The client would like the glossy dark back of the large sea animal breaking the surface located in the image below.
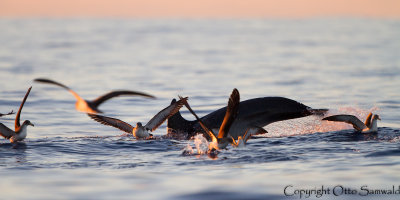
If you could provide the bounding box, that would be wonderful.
[167,97,328,139]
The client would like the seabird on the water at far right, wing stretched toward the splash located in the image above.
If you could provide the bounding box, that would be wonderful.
[322,113,381,133]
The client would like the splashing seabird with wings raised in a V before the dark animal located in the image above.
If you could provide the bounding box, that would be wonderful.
[181,88,260,152]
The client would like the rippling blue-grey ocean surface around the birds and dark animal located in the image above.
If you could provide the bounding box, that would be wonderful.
[0,18,400,199]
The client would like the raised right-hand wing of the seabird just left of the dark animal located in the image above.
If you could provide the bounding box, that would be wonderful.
[145,97,188,131]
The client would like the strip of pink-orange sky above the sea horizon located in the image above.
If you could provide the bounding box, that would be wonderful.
[0,0,400,18]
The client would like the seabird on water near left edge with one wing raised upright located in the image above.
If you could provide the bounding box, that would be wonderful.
[0,87,34,143]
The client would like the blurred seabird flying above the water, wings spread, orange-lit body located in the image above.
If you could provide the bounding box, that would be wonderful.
[34,78,155,113]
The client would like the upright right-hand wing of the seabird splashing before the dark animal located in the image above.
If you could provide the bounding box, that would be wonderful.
[218,88,240,138]
